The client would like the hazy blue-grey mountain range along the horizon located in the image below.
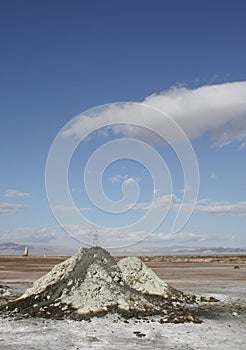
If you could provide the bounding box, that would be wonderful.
[0,242,246,256]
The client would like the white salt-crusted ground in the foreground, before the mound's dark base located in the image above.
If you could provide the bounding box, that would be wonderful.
[0,304,246,350]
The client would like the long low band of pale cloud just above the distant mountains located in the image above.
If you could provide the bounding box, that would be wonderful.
[0,225,237,250]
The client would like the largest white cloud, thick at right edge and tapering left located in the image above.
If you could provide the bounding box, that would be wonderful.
[63,81,246,146]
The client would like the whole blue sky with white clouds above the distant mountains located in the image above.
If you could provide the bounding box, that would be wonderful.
[0,0,246,249]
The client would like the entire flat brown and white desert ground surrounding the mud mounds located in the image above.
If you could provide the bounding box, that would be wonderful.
[0,256,246,350]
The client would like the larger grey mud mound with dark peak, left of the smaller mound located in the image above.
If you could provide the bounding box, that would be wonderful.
[1,247,200,323]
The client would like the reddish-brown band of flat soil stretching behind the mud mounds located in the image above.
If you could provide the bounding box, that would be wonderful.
[0,256,246,289]
